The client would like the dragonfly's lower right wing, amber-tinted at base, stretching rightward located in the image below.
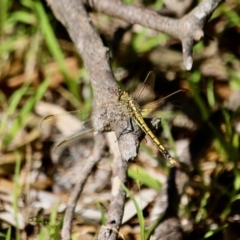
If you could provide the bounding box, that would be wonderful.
[141,89,186,118]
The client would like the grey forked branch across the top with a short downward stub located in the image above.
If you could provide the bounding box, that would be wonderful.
[85,0,222,70]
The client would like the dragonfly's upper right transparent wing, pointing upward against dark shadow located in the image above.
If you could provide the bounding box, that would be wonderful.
[132,71,155,105]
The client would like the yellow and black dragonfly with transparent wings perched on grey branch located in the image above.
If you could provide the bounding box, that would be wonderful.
[41,71,186,166]
